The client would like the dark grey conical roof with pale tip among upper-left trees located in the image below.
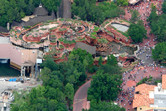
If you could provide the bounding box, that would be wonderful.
[33,4,48,16]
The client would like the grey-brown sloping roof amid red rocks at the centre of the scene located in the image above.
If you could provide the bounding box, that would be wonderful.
[75,42,96,55]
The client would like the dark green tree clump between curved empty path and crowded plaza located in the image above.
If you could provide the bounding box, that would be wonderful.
[88,55,122,102]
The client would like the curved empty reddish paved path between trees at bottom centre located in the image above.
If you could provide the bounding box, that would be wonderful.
[73,80,91,111]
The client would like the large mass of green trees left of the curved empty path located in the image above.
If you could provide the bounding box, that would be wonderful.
[11,49,93,111]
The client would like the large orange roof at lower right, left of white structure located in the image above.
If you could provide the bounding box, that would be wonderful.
[133,84,156,108]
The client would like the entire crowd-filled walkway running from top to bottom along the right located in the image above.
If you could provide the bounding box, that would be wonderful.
[116,0,166,111]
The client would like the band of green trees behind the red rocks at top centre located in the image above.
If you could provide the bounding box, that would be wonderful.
[72,0,124,25]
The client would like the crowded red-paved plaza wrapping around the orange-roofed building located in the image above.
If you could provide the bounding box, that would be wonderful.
[117,62,166,110]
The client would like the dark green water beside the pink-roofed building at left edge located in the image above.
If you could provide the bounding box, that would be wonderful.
[0,63,20,77]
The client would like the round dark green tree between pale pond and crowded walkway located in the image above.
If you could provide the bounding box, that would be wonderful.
[128,24,146,43]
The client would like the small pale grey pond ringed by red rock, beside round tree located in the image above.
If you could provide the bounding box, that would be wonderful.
[111,23,129,32]
